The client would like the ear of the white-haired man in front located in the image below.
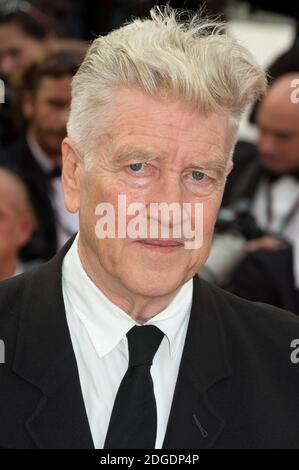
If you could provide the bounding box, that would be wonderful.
[61,138,83,213]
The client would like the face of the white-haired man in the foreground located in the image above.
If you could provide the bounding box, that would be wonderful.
[64,90,232,297]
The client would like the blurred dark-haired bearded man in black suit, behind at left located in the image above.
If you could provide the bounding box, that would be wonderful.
[0,41,86,260]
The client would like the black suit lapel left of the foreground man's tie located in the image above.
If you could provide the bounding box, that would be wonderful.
[14,239,93,449]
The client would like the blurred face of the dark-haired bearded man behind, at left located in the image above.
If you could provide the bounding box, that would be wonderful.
[25,76,71,158]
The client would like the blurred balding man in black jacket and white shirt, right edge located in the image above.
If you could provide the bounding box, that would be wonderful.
[224,72,299,314]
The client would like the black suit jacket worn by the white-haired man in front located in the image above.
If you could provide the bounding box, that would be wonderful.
[0,242,299,449]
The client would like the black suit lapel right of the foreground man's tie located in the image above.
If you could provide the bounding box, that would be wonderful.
[163,276,232,449]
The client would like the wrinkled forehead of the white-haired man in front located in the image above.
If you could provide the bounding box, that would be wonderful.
[102,90,236,162]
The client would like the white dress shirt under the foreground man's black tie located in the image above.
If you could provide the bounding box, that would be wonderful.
[62,235,193,449]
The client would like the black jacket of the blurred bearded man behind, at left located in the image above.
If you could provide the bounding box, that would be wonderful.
[0,137,57,261]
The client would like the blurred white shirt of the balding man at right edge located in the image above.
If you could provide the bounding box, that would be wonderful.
[252,176,299,289]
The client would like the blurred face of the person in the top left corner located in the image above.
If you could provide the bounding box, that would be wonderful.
[0,24,44,83]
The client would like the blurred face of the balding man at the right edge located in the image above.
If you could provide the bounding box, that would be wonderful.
[257,78,299,174]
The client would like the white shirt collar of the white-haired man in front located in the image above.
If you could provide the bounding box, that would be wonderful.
[62,234,193,358]
